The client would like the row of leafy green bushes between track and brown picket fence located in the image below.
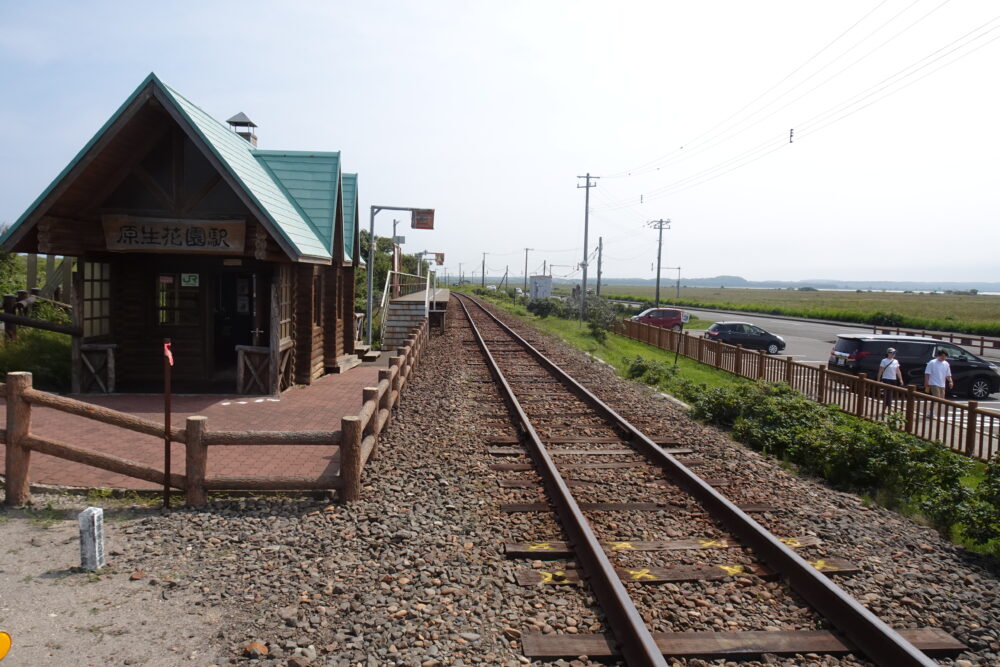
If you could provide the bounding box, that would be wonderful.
[680,378,1000,545]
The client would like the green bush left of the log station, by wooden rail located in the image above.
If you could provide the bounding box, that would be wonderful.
[0,327,70,392]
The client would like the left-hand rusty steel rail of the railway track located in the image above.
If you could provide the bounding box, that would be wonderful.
[458,298,667,667]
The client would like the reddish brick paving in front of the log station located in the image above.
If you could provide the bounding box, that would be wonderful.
[0,362,388,489]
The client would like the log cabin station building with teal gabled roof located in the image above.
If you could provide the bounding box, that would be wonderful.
[0,74,361,394]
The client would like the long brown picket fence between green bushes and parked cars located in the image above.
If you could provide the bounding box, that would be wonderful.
[615,320,1000,460]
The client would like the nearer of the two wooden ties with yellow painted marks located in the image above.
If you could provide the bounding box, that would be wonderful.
[514,558,861,586]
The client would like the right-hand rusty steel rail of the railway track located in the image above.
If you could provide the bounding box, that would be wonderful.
[463,295,938,667]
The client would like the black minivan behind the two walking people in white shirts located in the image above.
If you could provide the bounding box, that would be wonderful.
[830,334,1000,400]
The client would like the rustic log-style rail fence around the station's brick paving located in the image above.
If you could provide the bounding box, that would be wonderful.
[0,319,428,506]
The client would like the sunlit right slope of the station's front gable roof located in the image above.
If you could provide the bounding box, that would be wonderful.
[159,81,339,259]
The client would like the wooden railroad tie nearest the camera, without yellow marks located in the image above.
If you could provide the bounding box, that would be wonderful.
[521,628,966,660]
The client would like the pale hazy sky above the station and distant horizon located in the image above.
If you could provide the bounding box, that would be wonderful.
[0,0,1000,281]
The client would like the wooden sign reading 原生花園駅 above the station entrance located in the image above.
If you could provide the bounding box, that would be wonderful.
[101,215,246,255]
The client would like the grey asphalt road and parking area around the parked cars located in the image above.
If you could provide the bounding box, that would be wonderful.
[685,308,1000,407]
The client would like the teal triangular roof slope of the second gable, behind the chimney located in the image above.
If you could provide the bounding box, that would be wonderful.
[253,150,340,257]
